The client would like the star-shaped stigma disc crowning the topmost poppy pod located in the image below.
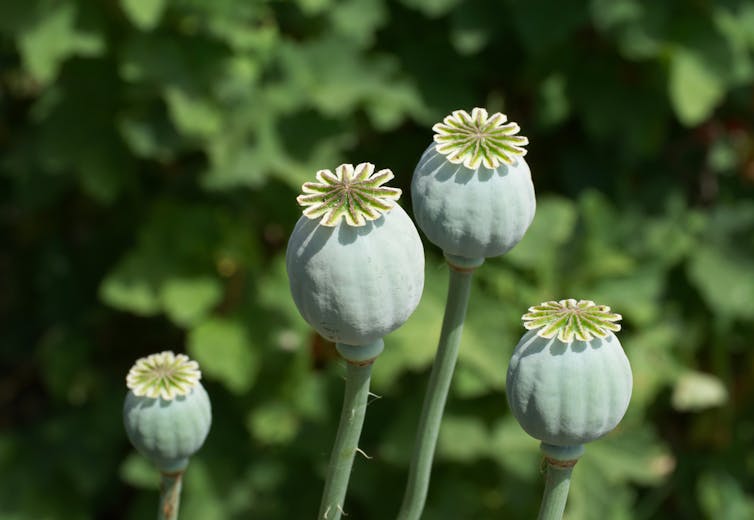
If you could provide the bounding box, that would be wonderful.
[432,108,529,170]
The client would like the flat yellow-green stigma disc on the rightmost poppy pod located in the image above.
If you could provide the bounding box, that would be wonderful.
[521,298,621,343]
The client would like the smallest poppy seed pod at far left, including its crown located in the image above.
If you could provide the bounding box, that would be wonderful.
[123,351,212,472]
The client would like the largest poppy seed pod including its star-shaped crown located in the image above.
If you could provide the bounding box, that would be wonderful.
[286,163,424,345]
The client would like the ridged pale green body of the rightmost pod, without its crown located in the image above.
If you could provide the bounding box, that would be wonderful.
[506,330,633,446]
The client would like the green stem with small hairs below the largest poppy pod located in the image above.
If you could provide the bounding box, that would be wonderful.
[318,352,372,520]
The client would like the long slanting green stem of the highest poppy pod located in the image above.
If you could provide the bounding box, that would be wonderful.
[397,258,482,520]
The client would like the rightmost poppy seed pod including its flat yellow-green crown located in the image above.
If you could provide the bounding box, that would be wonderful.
[505,299,632,446]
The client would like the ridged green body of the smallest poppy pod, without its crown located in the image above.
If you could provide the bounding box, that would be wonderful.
[123,383,212,471]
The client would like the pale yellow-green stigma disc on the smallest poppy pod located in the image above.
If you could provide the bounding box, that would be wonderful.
[126,351,202,401]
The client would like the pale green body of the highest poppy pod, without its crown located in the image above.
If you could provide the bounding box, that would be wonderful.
[411,143,536,258]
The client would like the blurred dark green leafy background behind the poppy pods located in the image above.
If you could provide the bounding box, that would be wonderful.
[0,0,754,520]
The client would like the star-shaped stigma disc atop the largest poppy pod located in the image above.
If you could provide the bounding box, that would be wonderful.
[296,163,401,227]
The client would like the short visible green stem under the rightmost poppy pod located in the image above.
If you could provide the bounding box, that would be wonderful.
[537,443,584,520]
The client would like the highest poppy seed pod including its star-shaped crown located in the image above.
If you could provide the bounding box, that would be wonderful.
[411,108,536,258]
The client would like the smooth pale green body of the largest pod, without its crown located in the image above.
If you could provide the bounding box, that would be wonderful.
[286,205,424,345]
